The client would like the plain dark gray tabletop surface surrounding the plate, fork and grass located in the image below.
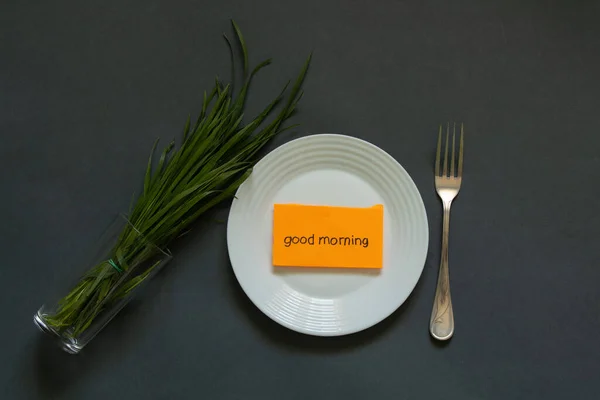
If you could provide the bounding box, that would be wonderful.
[0,0,600,400]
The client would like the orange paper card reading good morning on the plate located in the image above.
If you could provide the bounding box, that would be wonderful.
[273,204,383,268]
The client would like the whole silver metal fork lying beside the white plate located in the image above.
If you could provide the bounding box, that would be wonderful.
[429,123,464,340]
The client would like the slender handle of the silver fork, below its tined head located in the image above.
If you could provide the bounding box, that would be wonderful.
[429,201,454,340]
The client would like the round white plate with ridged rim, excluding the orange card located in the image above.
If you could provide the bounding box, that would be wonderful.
[227,134,429,336]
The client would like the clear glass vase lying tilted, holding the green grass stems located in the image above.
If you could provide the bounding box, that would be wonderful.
[33,215,172,354]
